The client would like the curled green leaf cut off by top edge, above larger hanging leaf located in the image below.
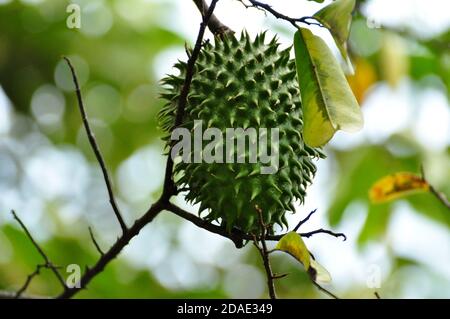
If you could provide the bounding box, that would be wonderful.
[314,0,355,73]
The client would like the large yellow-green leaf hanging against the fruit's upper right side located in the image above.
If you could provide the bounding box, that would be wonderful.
[294,28,363,147]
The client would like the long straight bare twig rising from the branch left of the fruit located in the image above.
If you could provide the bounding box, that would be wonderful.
[64,57,127,233]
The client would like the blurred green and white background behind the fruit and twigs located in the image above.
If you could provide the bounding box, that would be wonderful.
[0,0,450,298]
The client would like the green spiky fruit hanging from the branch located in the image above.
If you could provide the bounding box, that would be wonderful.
[160,33,323,234]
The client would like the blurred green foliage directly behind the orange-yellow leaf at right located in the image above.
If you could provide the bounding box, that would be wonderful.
[328,146,450,243]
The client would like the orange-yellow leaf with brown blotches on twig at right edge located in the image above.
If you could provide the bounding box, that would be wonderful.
[369,172,430,203]
